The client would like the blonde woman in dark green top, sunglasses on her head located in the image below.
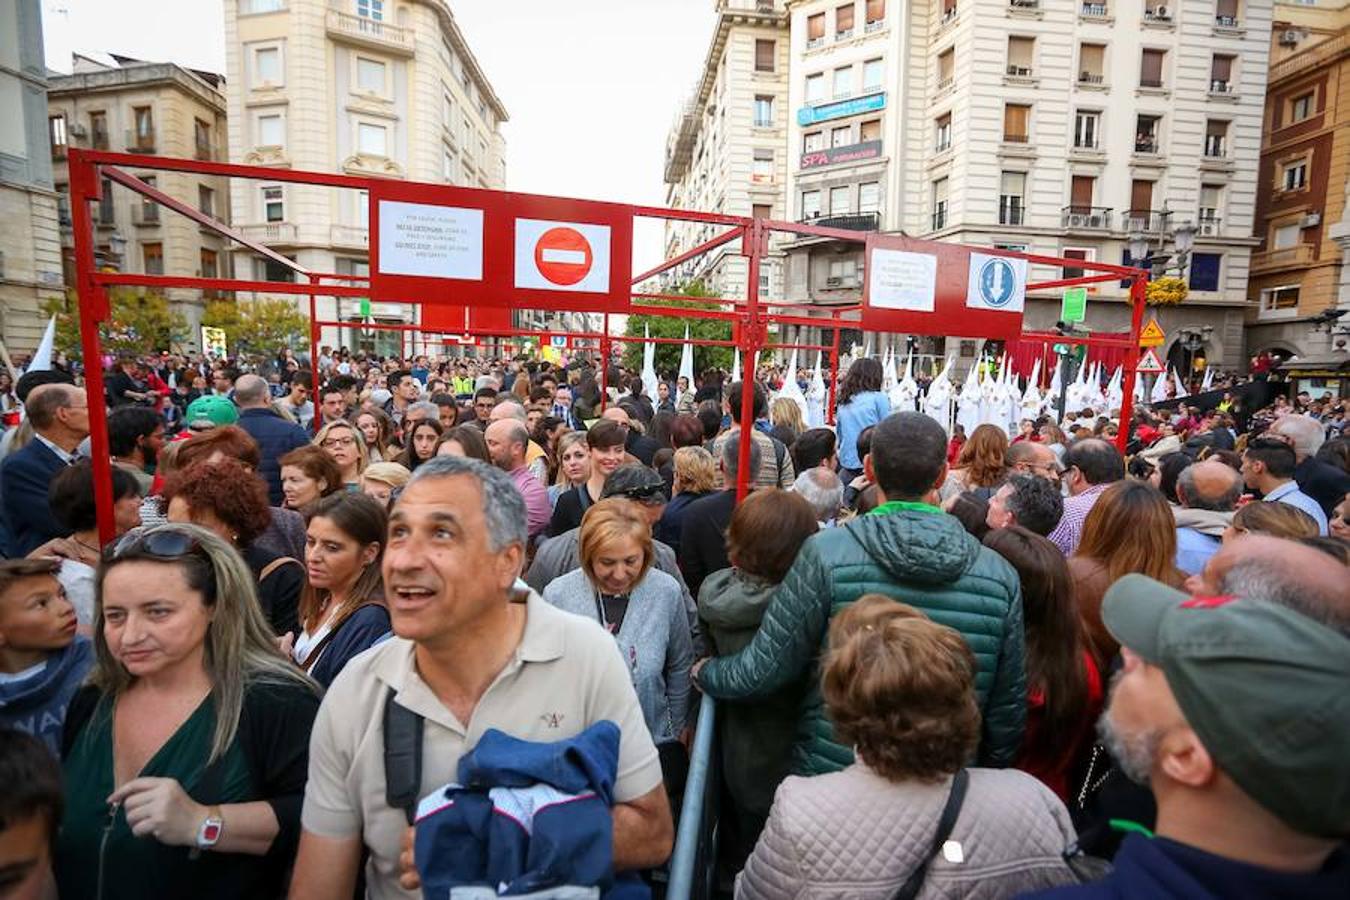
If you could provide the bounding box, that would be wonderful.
[54,525,319,900]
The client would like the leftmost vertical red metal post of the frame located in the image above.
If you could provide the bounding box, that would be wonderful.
[70,150,117,545]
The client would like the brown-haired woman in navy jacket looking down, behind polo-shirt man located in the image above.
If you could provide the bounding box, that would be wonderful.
[282,494,389,687]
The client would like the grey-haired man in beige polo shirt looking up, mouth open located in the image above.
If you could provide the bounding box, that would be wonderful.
[290,456,674,900]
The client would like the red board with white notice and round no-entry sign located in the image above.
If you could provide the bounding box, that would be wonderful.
[370,182,633,313]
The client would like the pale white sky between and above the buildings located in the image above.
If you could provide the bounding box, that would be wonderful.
[42,0,716,271]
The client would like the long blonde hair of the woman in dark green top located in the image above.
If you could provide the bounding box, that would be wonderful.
[89,524,319,765]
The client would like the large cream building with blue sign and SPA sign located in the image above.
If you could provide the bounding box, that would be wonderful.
[787,0,1270,370]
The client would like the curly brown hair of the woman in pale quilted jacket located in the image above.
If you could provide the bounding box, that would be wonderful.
[821,594,980,781]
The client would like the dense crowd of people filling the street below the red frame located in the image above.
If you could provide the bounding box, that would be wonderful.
[0,342,1350,900]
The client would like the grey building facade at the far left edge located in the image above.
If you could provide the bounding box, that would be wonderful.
[0,0,65,363]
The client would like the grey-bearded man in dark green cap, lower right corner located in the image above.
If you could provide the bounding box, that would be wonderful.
[1026,575,1350,900]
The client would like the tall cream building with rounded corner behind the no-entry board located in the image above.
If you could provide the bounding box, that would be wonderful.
[224,0,506,354]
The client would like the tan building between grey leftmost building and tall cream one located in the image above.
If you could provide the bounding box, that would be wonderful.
[47,54,230,343]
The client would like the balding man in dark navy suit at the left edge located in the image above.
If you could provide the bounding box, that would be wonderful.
[0,385,89,556]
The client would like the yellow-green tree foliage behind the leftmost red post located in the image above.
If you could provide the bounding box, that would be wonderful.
[42,287,189,359]
